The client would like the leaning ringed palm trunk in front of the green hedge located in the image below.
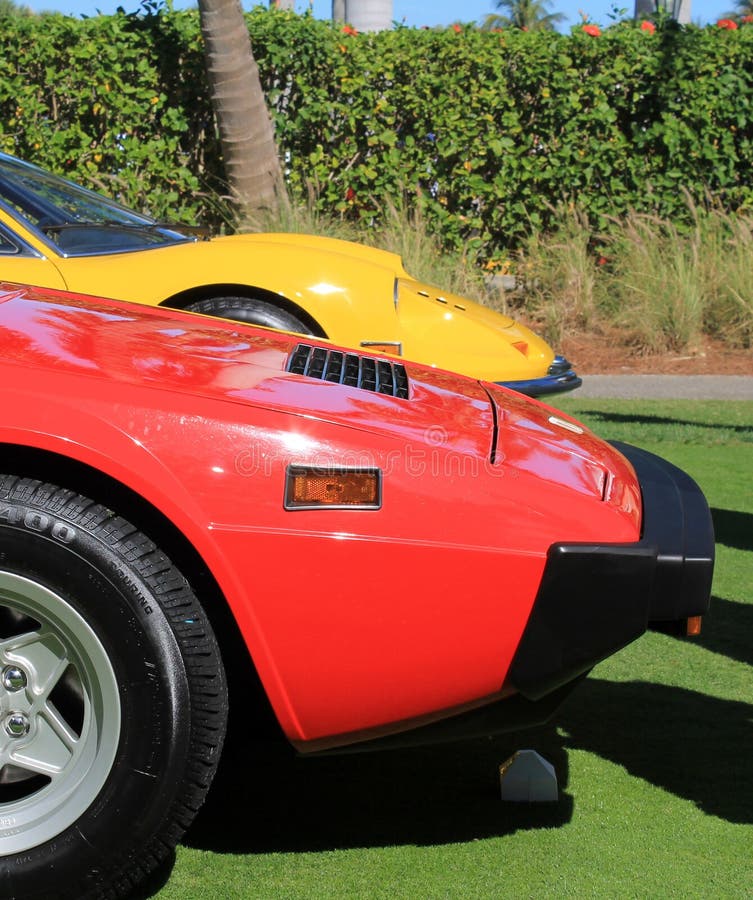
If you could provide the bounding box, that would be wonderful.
[199,0,282,210]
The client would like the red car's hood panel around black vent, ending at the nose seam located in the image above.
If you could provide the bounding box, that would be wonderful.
[0,285,494,458]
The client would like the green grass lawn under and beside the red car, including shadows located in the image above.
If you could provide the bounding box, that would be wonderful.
[151,397,753,900]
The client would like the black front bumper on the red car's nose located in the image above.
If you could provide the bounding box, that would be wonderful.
[509,443,714,700]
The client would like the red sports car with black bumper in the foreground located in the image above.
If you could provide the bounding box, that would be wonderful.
[0,285,713,898]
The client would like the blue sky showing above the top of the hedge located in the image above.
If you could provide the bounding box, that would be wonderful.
[27,0,735,28]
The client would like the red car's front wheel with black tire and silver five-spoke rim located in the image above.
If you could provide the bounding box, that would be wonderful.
[0,475,227,900]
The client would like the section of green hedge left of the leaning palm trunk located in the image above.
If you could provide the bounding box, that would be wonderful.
[0,14,221,219]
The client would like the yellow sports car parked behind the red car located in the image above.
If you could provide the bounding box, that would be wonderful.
[0,154,581,396]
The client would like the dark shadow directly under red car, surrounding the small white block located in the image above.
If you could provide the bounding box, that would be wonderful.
[183,728,572,853]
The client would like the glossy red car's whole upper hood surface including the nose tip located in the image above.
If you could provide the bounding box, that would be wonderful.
[0,285,639,518]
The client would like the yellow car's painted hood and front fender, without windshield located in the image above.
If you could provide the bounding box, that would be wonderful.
[10,221,554,381]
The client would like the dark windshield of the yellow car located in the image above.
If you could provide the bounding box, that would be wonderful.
[0,154,191,255]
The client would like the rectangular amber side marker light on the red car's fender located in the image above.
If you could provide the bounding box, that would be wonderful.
[284,466,382,509]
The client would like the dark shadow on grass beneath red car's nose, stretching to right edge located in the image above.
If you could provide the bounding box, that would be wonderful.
[184,679,753,854]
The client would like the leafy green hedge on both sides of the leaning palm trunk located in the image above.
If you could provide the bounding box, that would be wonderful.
[0,5,753,258]
